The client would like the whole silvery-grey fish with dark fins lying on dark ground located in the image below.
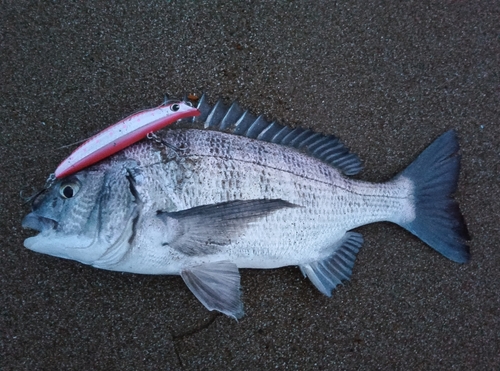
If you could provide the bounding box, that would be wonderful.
[22,95,470,319]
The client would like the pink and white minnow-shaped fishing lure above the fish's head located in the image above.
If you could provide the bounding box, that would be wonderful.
[55,102,200,178]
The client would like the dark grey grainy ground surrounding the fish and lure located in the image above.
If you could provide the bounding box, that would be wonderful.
[0,0,500,370]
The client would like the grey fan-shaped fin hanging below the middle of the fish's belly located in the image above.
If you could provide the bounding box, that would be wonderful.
[181,261,244,319]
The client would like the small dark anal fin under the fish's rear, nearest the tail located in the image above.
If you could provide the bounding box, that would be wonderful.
[300,232,363,296]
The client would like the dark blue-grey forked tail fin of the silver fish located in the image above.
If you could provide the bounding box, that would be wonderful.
[399,130,470,263]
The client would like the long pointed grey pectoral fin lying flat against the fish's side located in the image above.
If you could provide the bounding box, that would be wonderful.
[158,199,296,256]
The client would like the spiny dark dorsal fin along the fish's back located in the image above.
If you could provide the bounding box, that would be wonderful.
[184,94,362,175]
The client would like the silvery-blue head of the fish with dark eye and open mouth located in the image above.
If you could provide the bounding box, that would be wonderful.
[22,163,140,269]
